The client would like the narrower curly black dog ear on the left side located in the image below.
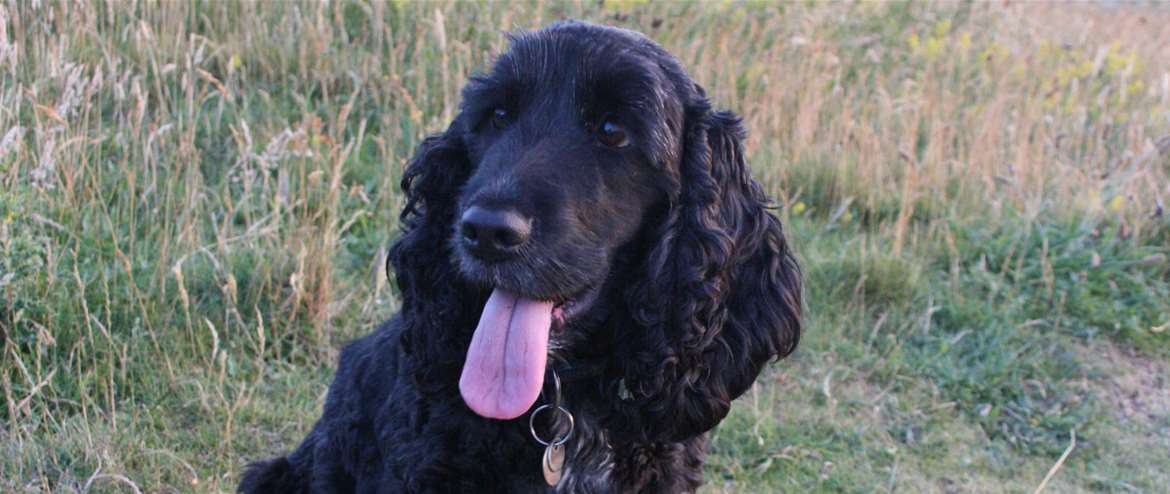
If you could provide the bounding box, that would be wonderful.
[386,118,472,313]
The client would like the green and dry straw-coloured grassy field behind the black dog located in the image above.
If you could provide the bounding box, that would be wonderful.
[0,0,1170,493]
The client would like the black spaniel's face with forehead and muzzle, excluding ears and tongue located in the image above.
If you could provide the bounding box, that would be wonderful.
[452,27,683,318]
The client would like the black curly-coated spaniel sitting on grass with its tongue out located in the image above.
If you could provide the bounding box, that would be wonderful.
[240,22,800,493]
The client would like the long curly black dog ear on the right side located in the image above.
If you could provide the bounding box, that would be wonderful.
[619,94,801,441]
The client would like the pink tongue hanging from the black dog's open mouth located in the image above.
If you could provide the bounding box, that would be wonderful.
[459,289,552,419]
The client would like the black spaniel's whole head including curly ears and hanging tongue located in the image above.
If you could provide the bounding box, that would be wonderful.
[391,22,800,430]
